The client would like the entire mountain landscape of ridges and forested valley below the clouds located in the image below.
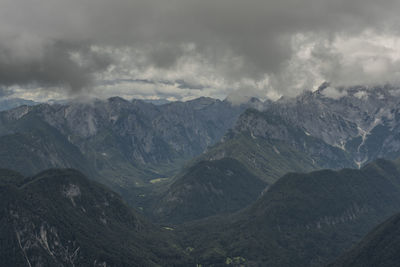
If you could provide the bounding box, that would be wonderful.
[0,83,400,266]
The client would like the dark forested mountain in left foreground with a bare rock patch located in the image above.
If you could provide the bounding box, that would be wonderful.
[0,169,189,266]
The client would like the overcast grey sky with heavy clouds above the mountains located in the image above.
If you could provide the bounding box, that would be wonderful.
[0,0,400,101]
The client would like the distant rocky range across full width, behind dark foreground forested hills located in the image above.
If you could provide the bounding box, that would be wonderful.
[0,84,400,220]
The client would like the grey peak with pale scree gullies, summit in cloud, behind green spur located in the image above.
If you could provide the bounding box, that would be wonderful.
[266,83,400,166]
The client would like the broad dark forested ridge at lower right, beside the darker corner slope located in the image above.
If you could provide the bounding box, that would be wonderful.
[177,160,400,266]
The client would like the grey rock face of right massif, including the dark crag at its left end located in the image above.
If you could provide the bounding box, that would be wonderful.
[235,84,400,167]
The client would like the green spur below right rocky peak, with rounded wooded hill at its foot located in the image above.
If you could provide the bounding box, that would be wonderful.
[152,109,348,223]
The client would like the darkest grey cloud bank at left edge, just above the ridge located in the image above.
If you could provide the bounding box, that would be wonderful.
[0,39,111,92]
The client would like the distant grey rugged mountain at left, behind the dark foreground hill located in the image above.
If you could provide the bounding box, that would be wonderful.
[0,97,255,204]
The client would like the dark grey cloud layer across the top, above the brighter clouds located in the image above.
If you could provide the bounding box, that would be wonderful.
[0,0,400,96]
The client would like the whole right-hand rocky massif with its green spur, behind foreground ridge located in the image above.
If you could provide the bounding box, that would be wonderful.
[148,84,400,223]
